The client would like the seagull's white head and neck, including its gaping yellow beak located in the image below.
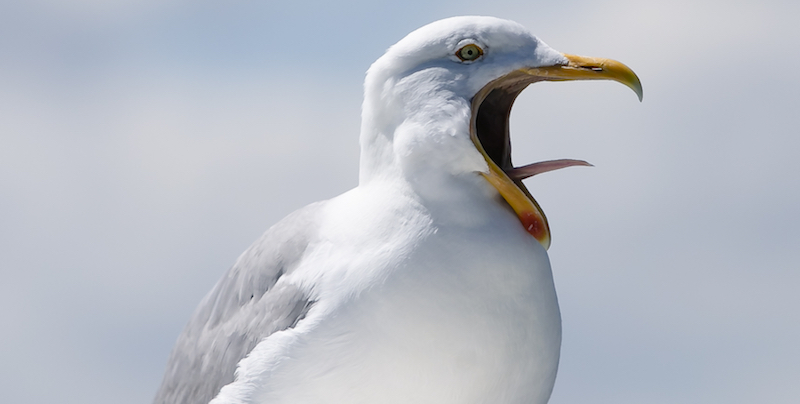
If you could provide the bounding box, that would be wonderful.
[359,17,642,248]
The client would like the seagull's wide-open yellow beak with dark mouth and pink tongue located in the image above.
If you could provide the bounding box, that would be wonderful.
[470,54,642,249]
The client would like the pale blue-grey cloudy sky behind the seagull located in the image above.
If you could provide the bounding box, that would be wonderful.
[0,0,800,404]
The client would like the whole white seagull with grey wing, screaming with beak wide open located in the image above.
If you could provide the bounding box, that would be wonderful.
[155,17,642,404]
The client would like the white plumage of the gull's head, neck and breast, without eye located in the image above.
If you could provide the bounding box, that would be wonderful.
[212,17,563,404]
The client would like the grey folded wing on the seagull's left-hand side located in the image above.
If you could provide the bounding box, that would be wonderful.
[154,202,324,404]
